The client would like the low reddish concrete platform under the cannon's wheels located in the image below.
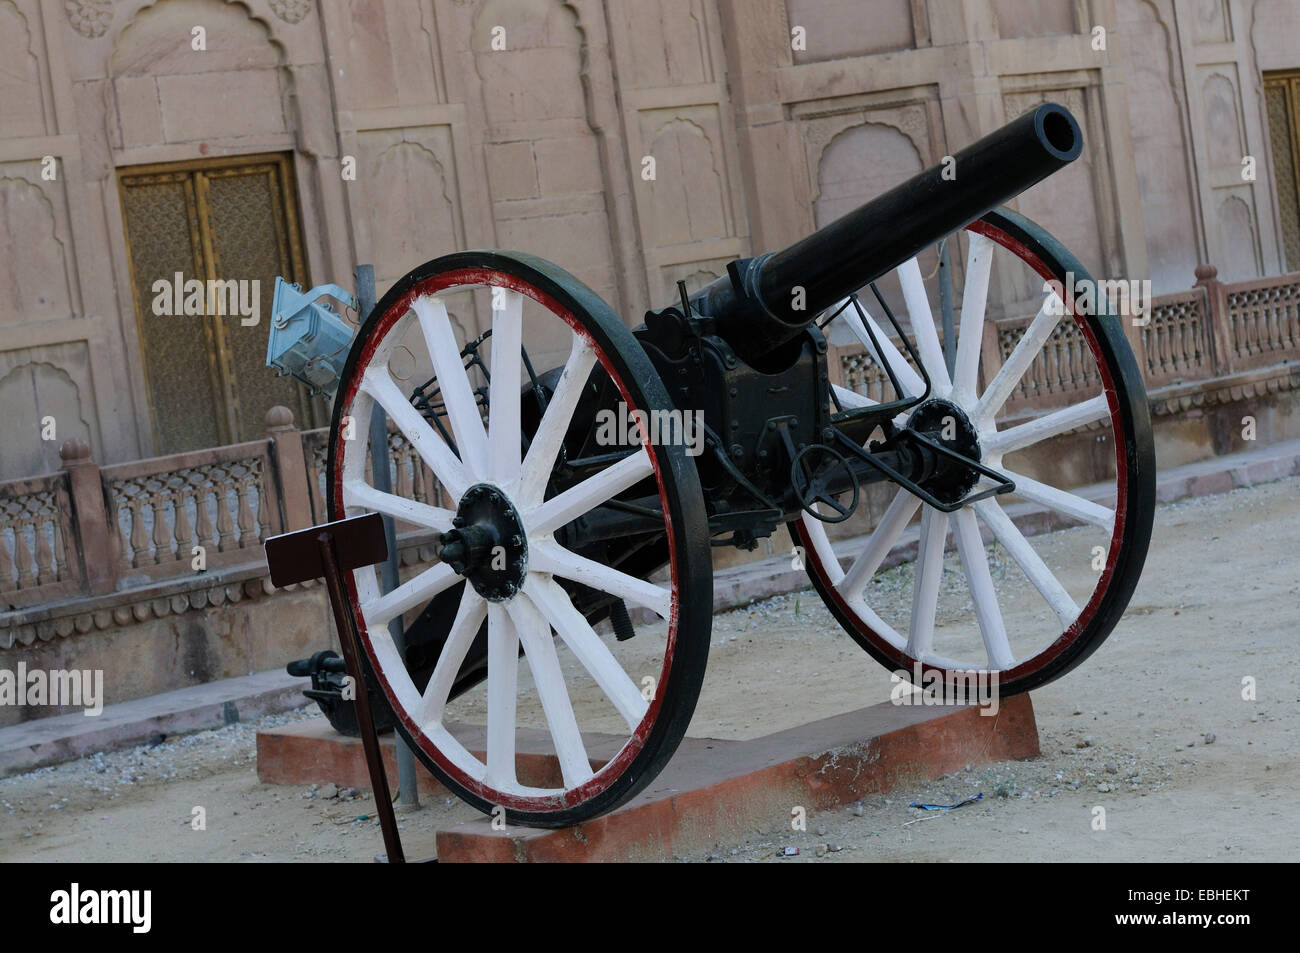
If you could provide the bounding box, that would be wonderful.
[257,696,1039,863]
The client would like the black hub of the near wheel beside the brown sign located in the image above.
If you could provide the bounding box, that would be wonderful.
[438,484,528,602]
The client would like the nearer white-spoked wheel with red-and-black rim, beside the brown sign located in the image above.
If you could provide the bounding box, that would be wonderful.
[328,252,712,827]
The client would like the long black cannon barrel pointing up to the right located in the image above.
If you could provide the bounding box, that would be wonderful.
[690,103,1083,363]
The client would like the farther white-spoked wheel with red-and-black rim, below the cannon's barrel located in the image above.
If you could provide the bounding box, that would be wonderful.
[789,209,1156,696]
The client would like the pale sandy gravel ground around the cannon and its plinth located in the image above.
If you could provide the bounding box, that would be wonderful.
[0,480,1300,863]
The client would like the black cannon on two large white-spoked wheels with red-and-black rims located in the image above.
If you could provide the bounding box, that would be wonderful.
[268,104,1154,827]
